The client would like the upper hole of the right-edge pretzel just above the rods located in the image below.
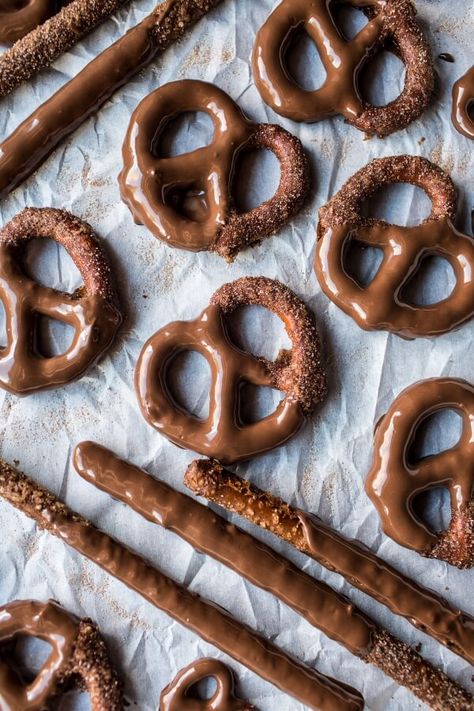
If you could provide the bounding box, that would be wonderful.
[406,407,463,466]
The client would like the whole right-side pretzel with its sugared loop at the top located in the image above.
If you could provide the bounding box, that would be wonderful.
[315,156,474,338]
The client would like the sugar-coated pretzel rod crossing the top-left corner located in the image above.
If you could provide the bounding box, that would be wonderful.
[0,0,130,96]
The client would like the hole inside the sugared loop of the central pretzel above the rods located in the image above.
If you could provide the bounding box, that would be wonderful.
[226,305,291,360]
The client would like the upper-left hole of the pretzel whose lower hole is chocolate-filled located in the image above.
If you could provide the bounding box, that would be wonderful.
[156,111,214,158]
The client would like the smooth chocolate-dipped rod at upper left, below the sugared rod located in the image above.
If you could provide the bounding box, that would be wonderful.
[0,0,221,198]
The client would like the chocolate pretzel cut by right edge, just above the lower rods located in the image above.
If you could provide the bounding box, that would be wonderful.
[366,378,474,568]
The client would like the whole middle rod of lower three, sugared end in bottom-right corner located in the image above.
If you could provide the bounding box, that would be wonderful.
[74,442,474,710]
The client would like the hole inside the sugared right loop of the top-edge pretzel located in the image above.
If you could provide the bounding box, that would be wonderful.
[357,50,406,106]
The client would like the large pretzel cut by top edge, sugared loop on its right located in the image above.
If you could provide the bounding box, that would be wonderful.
[253,0,434,136]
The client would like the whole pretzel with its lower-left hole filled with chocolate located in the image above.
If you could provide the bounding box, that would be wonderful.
[119,80,309,260]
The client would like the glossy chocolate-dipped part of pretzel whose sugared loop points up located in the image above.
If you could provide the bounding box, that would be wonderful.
[315,218,474,338]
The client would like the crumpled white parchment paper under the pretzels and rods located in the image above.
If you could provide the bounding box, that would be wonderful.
[0,0,474,711]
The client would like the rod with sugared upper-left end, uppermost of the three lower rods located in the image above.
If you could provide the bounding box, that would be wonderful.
[184,459,474,664]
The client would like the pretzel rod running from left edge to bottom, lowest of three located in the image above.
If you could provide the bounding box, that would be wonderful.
[0,460,362,711]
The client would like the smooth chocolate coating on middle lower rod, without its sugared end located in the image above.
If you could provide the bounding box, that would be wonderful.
[74,442,375,657]
